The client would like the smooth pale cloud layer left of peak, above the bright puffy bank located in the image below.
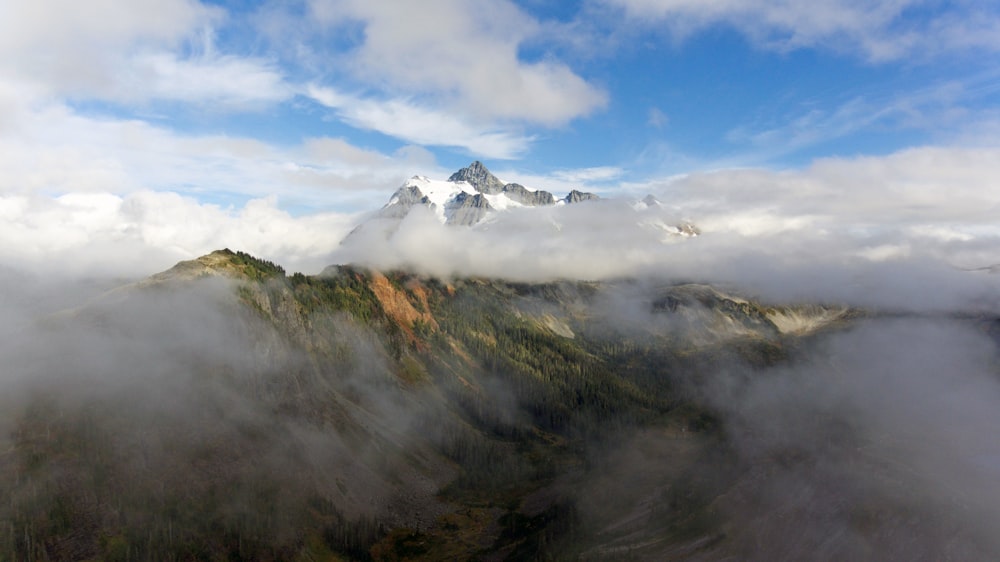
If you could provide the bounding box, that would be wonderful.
[0,88,436,205]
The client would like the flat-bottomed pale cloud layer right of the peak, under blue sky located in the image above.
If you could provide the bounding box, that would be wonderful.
[664,147,1000,231]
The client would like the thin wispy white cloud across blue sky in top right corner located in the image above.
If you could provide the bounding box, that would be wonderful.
[606,0,1000,62]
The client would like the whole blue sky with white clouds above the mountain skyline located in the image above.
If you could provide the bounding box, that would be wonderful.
[0,0,1000,276]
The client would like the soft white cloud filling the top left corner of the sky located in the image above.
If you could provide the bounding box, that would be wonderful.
[0,0,293,110]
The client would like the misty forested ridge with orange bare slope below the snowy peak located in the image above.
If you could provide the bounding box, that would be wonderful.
[0,250,856,561]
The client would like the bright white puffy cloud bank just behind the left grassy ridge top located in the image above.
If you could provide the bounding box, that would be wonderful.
[0,191,356,277]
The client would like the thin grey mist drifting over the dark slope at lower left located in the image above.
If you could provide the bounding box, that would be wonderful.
[0,269,456,540]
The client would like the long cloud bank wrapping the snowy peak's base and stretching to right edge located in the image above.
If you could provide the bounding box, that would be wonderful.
[334,143,1000,310]
